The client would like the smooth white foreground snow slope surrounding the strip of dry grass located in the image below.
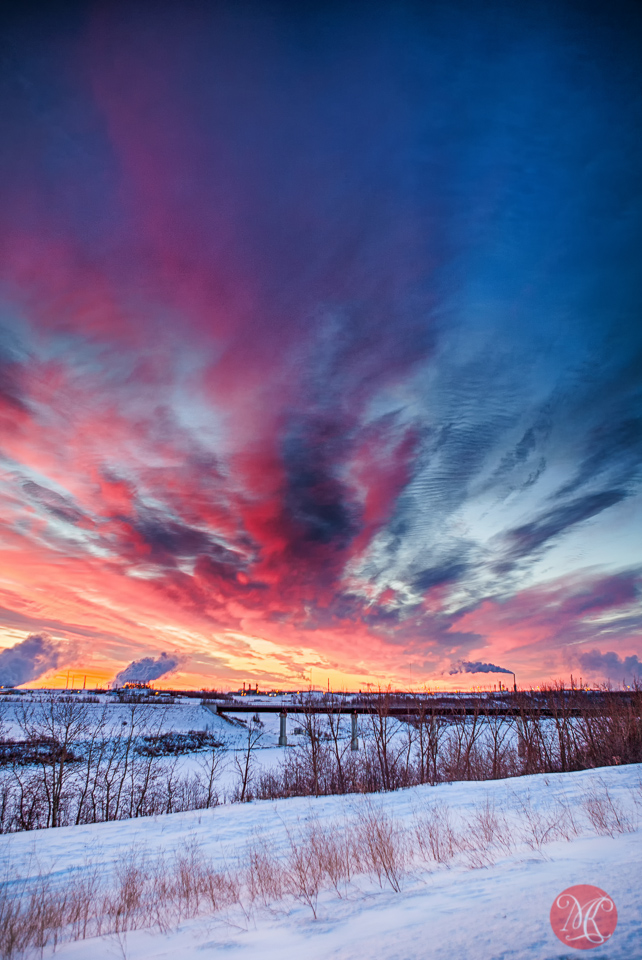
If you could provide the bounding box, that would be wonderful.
[0,766,642,960]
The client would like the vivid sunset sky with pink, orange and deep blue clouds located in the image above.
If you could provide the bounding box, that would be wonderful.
[0,0,642,689]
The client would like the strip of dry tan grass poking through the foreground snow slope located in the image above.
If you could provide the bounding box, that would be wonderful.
[0,778,637,960]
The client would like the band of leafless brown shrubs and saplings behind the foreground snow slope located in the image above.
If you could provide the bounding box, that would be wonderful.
[0,683,642,833]
